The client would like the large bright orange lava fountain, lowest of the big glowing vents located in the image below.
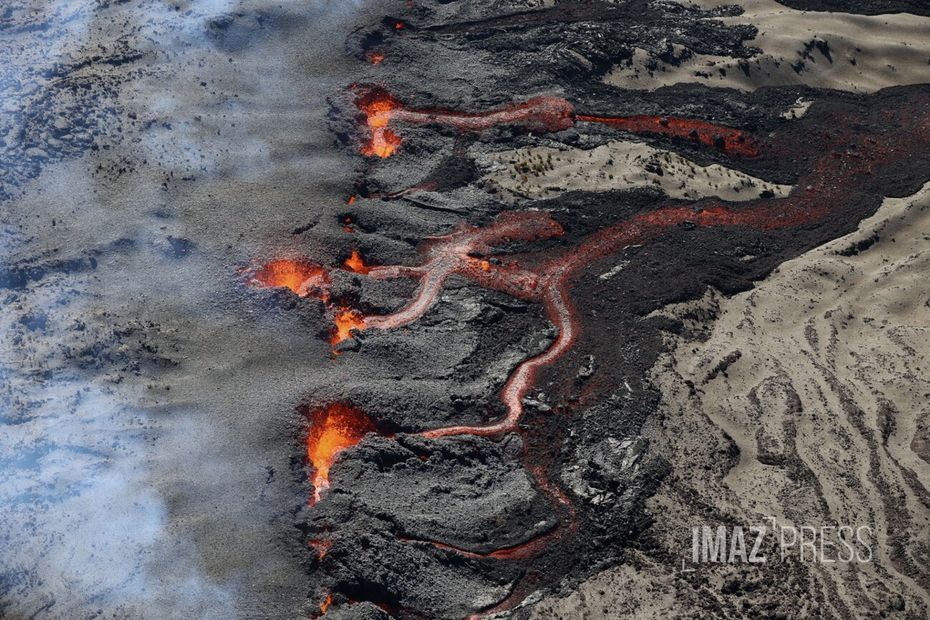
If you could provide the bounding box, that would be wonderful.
[307,403,375,504]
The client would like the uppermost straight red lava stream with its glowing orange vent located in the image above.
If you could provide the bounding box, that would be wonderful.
[355,87,759,158]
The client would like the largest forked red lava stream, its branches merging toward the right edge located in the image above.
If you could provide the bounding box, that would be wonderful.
[332,97,930,438]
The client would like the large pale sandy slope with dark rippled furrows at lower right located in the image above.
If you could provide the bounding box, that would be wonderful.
[534,180,930,619]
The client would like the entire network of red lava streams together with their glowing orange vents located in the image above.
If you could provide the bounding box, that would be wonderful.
[286,83,930,613]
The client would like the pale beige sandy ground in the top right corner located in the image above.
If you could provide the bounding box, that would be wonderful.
[605,0,930,92]
